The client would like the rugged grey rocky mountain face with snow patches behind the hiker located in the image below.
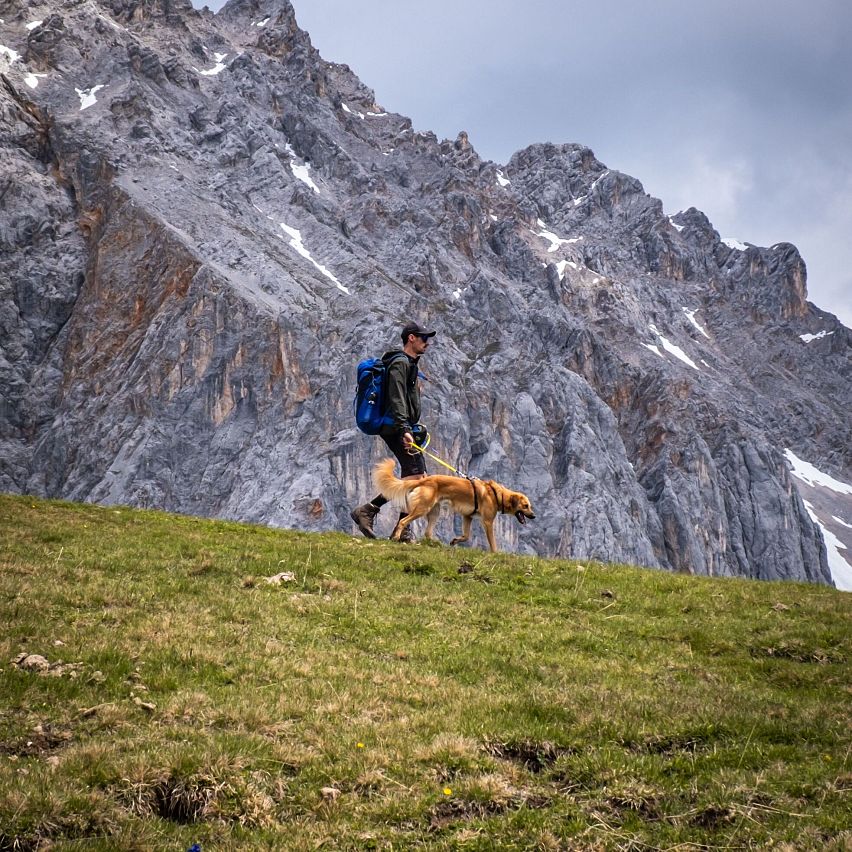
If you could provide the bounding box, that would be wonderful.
[0,0,852,583]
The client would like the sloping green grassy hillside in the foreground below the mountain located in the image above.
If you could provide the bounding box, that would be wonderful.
[0,497,852,850]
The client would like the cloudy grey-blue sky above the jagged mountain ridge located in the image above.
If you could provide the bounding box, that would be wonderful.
[194,0,852,326]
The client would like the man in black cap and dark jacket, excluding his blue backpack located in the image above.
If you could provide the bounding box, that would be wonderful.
[350,322,437,544]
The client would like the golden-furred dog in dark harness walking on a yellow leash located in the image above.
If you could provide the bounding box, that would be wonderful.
[373,459,535,553]
